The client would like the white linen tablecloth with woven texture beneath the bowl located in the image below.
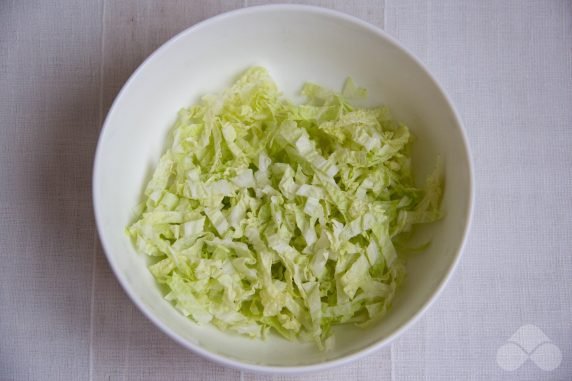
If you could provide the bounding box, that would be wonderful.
[0,0,572,381]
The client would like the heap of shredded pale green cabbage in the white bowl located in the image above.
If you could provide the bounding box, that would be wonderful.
[127,67,442,348]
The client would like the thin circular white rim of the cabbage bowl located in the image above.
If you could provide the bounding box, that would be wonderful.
[92,4,475,375]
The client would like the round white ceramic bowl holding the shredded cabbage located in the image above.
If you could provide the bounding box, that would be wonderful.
[93,5,473,373]
